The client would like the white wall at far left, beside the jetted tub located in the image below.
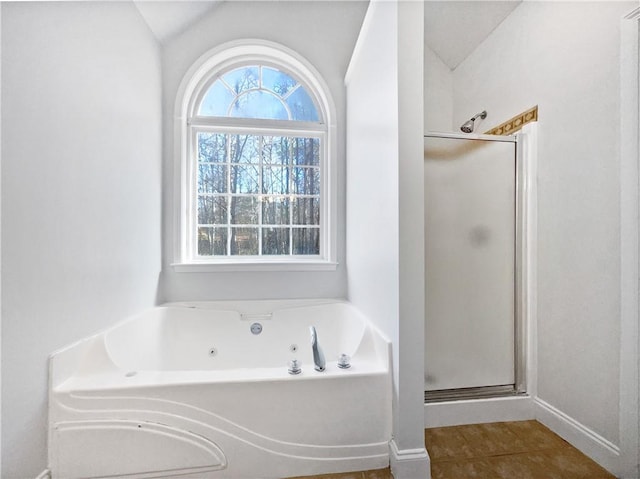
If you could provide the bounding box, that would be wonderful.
[2,2,161,479]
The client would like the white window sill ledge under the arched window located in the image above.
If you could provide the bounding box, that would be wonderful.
[171,260,338,273]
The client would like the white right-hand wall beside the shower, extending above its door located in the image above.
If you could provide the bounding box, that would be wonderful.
[453,2,637,472]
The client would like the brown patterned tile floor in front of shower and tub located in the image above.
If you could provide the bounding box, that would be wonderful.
[291,421,615,479]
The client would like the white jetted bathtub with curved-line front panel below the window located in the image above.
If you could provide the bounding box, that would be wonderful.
[49,300,392,479]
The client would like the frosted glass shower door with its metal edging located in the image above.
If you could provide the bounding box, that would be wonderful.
[424,133,527,403]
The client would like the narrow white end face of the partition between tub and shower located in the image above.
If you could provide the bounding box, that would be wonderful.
[394,1,429,464]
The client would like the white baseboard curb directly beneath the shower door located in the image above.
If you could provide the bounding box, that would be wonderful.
[424,396,535,428]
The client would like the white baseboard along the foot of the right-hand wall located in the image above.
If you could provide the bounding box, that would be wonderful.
[534,398,621,476]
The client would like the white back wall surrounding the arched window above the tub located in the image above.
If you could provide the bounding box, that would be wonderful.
[163,1,367,301]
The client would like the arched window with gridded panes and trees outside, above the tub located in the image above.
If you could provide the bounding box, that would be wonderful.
[179,43,334,265]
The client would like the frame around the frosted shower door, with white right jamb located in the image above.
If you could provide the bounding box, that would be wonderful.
[424,129,536,404]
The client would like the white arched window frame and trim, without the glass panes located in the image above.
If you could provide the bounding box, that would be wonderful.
[172,40,337,272]
